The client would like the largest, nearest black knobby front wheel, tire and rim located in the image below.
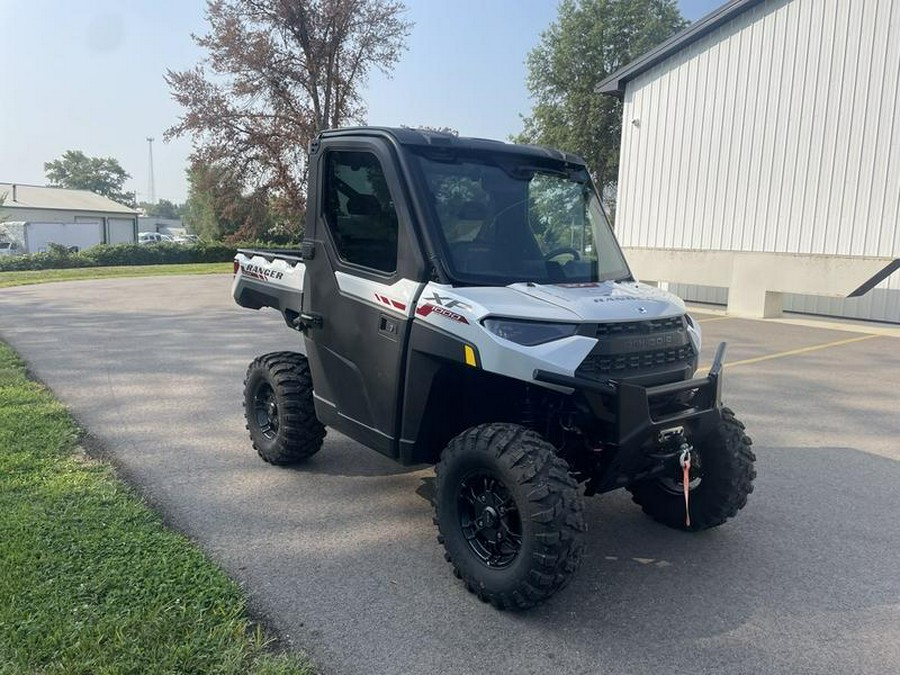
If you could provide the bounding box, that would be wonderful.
[435,424,586,610]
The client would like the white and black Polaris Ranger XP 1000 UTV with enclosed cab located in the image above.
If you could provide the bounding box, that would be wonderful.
[232,128,756,609]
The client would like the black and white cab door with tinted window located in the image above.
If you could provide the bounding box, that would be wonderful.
[303,138,424,458]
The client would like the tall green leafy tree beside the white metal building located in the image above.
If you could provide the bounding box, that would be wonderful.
[516,0,687,203]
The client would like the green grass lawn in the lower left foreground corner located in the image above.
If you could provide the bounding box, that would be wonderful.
[0,343,313,675]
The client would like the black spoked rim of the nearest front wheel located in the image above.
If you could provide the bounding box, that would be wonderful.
[458,471,522,568]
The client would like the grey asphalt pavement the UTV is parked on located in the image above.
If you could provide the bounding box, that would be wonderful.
[0,276,900,674]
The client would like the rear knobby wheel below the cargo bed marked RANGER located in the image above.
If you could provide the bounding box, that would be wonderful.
[244,352,325,464]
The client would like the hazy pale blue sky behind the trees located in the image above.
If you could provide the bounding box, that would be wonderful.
[0,0,724,203]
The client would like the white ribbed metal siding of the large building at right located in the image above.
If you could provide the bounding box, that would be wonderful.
[616,0,900,321]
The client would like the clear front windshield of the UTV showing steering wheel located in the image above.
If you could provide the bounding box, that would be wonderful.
[419,154,630,285]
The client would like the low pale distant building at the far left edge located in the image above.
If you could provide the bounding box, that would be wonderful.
[0,183,138,253]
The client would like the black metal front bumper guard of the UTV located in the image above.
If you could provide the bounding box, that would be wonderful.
[533,342,726,492]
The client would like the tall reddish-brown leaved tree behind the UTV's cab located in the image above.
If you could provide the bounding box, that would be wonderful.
[166,0,411,231]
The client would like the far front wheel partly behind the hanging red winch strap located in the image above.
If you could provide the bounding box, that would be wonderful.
[628,408,756,531]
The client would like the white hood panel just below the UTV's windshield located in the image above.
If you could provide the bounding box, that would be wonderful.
[510,281,685,321]
